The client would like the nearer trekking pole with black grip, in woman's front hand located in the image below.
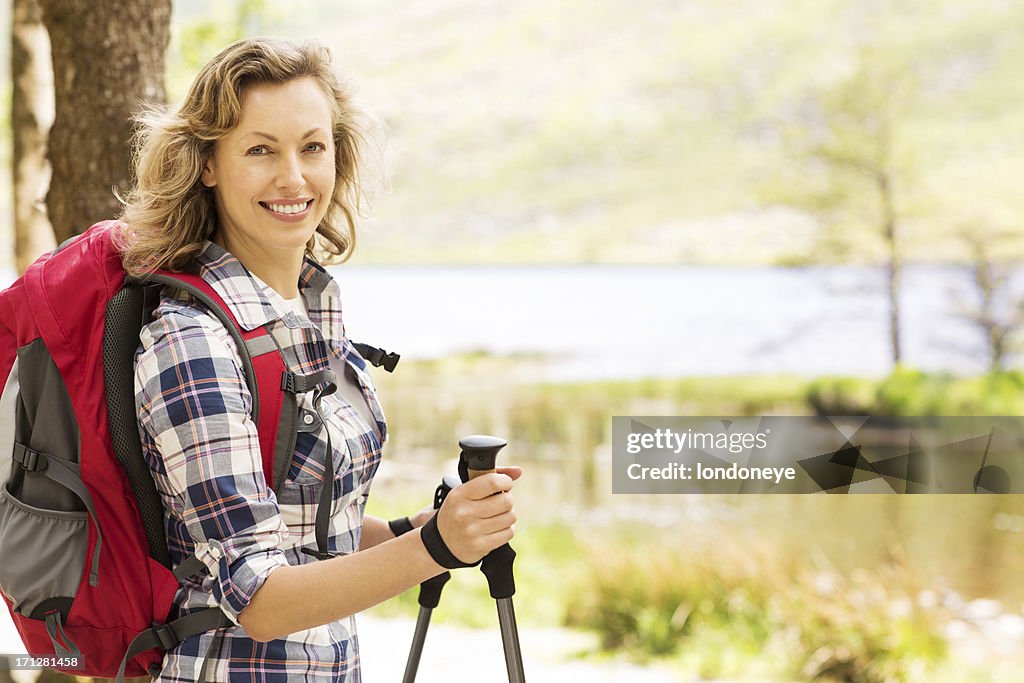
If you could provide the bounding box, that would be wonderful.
[459,434,526,683]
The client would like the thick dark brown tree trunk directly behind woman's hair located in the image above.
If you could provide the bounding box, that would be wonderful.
[40,0,171,242]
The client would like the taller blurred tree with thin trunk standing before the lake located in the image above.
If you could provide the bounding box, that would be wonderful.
[776,50,916,365]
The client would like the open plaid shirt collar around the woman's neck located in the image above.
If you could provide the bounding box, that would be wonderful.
[196,242,345,349]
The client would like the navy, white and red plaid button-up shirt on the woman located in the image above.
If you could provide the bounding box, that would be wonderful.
[135,243,387,683]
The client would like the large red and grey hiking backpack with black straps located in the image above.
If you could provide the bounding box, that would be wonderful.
[0,221,397,678]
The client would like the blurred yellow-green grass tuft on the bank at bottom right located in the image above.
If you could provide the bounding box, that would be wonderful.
[566,539,946,683]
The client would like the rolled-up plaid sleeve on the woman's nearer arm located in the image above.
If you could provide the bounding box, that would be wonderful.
[135,309,288,623]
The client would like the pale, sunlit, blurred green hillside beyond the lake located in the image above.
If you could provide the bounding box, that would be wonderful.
[4,0,1024,264]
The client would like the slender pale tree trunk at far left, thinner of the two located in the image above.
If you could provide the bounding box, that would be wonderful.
[10,0,53,273]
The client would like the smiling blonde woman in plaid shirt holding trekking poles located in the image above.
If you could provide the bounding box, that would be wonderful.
[122,39,521,681]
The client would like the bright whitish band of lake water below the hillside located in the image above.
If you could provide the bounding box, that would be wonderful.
[0,266,1003,380]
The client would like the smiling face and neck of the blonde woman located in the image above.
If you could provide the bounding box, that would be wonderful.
[202,78,335,297]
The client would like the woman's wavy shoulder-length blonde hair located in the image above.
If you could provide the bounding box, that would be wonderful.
[117,38,365,276]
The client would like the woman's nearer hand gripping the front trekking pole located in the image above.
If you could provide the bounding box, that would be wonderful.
[434,467,522,564]
